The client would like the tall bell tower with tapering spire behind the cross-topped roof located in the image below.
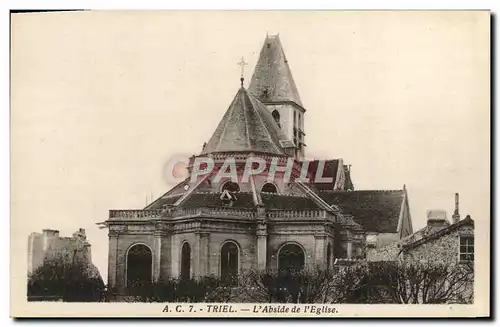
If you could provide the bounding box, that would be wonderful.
[248,35,306,160]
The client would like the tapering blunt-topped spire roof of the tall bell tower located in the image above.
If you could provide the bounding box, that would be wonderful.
[249,35,303,107]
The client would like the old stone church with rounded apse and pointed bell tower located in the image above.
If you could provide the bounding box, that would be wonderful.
[99,35,413,292]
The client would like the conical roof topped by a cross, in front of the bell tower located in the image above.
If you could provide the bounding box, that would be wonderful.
[202,87,292,155]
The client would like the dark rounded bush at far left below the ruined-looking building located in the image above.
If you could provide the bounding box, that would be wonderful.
[28,255,105,302]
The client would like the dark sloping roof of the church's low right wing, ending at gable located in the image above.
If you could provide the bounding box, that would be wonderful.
[318,190,404,233]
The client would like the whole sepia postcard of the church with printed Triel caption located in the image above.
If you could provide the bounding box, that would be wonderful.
[10,10,491,318]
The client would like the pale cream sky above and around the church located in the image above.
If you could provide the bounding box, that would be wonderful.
[11,11,490,280]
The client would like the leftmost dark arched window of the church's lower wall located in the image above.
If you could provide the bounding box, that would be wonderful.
[127,244,153,293]
